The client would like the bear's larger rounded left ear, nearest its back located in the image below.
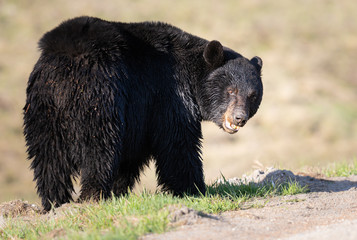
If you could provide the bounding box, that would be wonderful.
[203,40,224,67]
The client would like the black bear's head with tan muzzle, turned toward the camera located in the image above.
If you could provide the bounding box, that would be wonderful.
[199,41,263,134]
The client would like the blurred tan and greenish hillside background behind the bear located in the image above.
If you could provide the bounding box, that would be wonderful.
[0,0,357,202]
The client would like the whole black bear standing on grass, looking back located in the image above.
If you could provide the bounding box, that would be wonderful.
[24,17,263,210]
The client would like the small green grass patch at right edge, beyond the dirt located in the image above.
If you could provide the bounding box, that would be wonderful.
[323,160,357,177]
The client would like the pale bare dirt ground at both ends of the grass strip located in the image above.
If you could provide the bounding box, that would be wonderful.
[0,169,357,240]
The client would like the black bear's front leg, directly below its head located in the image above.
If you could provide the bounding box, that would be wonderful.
[154,122,206,196]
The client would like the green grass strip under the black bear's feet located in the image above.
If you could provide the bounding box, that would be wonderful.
[0,182,306,239]
